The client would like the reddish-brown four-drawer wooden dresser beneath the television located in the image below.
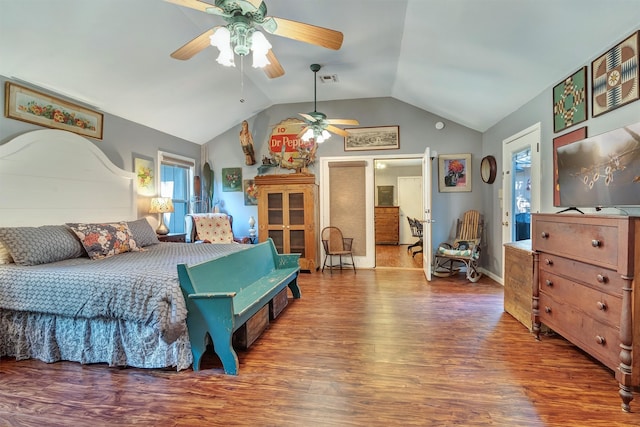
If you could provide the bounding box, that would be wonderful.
[532,214,640,412]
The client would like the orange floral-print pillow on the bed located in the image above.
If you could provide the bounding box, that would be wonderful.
[67,221,141,259]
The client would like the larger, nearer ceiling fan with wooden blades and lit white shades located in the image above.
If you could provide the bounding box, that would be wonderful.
[165,0,343,79]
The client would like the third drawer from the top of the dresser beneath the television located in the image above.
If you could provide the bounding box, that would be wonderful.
[540,271,622,327]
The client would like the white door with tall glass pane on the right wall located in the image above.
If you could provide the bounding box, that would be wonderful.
[502,123,540,277]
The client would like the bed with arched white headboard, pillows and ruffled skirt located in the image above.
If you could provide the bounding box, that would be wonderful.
[0,130,246,370]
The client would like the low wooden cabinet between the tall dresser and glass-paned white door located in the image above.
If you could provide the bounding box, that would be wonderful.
[504,240,533,331]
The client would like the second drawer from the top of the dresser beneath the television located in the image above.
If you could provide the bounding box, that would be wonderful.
[540,253,624,296]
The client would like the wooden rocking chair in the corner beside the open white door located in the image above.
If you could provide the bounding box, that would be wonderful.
[432,210,482,283]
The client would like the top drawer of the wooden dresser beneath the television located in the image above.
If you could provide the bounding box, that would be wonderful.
[533,219,619,269]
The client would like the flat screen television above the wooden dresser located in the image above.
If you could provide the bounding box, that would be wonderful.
[554,123,640,208]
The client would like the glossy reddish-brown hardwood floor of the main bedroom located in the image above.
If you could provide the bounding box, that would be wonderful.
[0,269,640,427]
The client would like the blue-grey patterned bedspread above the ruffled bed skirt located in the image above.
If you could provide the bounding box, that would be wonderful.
[0,243,246,343]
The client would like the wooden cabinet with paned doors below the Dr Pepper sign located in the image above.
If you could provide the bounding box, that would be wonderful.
[255,174,320,271]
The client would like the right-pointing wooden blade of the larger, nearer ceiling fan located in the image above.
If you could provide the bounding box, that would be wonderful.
[262,16,344,50]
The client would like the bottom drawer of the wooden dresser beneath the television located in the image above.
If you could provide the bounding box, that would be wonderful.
[540,293,620,371]
